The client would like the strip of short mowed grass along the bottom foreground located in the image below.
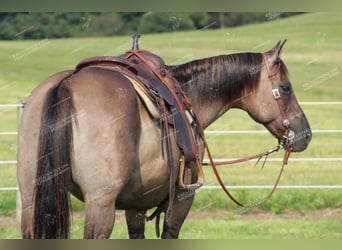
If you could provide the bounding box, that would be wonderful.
[0,211,342,240]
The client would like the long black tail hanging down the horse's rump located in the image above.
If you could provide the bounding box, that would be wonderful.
[33,74,75,239]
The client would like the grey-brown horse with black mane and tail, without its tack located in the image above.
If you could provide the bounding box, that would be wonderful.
[17,39,312,239]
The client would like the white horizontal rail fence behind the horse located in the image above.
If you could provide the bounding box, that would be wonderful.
[0,102,342,219]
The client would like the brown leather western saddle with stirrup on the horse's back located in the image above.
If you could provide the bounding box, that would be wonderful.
[76,34,204,219]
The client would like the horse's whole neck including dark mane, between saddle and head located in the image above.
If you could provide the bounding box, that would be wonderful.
[169,53,262,128]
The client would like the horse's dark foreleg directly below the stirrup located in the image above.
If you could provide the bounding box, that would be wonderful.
[161,189,195,239]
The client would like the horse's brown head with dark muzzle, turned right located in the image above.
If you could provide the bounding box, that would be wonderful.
[245,40,312,152]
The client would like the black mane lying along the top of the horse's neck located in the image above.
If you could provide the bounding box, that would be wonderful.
[167,53,263,103]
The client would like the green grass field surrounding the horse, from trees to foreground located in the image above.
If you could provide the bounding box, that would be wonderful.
[0,13,342,238]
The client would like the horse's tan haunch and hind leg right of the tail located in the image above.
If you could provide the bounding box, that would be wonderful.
[72,67,140,238]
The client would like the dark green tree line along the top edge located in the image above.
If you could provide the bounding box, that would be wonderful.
[0,12,301,40]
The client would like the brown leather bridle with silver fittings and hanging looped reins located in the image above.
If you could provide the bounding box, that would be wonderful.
[204,53,295,208]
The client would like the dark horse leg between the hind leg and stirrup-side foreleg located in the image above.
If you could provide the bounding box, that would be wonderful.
[125,209,146,239]
